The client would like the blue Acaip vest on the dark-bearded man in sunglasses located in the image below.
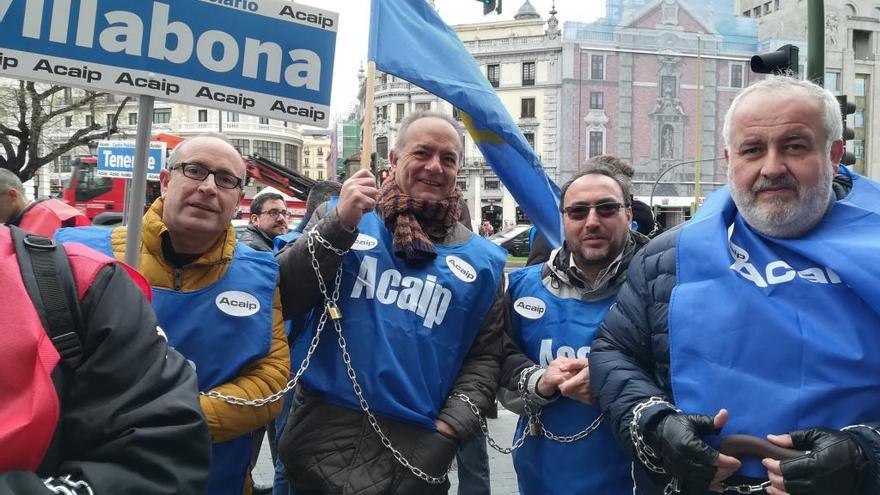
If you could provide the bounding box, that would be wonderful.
[509,265,633,495]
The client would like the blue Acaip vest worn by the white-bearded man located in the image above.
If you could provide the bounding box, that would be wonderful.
[669,169,880,478]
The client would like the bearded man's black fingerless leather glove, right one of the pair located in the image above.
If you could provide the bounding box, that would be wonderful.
[780,428,869,495]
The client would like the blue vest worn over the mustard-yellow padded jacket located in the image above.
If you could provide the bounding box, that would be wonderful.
[56,227,278,495]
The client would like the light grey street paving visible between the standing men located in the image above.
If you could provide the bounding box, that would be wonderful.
[253,405,518,495]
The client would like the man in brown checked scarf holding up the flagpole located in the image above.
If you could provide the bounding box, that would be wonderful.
[279,112,505,495]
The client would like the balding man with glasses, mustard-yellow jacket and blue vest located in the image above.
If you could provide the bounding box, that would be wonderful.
[57,136,290,495]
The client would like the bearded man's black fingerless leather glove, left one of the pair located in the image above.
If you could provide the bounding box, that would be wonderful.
[648,413,720,493]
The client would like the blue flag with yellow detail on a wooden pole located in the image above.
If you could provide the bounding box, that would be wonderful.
[369,0,561,246]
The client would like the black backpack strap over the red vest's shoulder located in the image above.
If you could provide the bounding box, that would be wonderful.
[10,226,83,370]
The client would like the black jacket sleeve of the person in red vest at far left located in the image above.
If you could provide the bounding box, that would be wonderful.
[0,265,211,495]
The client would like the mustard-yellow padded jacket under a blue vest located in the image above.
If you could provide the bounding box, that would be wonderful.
[111,198,290,443]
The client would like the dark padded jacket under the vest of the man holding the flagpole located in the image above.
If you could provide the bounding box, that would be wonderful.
[278,203,504,495]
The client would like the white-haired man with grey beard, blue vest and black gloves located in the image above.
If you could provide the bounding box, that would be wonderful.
[590,76,880,495]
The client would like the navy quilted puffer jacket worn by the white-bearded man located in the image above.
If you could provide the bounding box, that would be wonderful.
[590,178,880,495]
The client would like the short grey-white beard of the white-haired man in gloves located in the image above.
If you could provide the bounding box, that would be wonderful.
[728,167,833,238]
